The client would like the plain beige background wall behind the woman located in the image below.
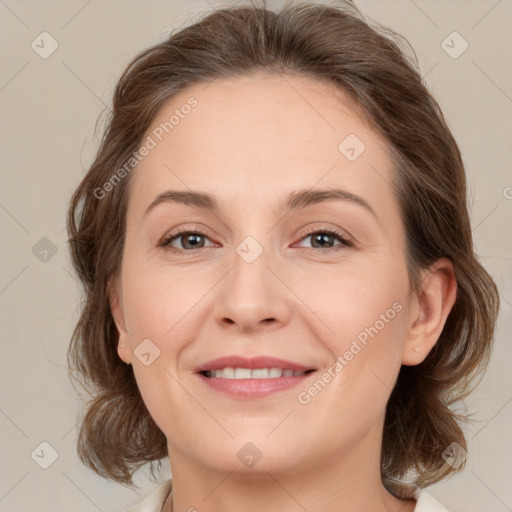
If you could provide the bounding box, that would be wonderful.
[0,0,512,512]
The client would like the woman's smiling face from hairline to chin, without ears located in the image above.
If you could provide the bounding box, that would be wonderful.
[113,74,413,472]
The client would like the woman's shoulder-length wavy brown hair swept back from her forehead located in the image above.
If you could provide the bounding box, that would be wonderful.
[67,1,499,497]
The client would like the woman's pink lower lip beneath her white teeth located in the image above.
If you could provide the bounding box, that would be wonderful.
[197,372,315,398]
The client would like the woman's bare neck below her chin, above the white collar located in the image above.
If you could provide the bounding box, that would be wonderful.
[162,433,415,512]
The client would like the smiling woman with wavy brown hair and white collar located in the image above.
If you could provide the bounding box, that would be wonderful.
[68,2,498,512]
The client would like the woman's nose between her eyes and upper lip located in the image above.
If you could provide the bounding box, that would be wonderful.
[214,242,293,333]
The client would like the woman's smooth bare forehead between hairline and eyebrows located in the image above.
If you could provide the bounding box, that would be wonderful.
[126,72,391,215]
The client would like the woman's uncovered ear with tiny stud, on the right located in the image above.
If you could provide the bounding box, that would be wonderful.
[402,258,457,366]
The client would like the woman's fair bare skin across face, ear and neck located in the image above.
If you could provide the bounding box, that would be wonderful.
[111,73,456,512]
